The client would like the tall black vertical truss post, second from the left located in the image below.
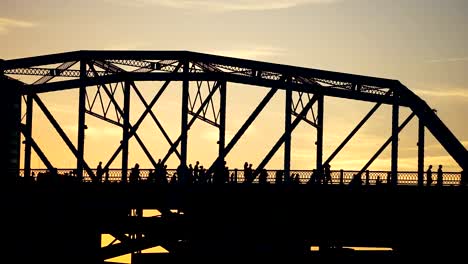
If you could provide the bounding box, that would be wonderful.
[76,60,86,181]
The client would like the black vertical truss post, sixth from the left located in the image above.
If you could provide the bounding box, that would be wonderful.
[284,84,292,182]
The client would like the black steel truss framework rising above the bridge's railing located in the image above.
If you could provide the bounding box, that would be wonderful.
[1,51,468,184]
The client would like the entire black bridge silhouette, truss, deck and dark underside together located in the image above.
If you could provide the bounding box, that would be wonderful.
[0,51,468,263]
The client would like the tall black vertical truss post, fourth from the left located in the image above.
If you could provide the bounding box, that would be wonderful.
[180,61,189,168]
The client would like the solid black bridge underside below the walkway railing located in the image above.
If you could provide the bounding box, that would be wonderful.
[5,184,468,263]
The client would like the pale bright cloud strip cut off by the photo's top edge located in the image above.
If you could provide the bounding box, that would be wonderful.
[106,0,339,12]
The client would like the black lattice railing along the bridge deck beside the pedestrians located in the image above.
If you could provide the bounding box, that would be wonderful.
[19,169,461,186]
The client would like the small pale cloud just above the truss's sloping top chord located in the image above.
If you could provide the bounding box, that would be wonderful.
[207,46,285,59]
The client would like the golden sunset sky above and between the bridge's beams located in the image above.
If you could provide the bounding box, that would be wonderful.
[0,0,468,171]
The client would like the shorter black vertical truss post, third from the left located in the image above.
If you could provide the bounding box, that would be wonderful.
[122,81,130,183]
